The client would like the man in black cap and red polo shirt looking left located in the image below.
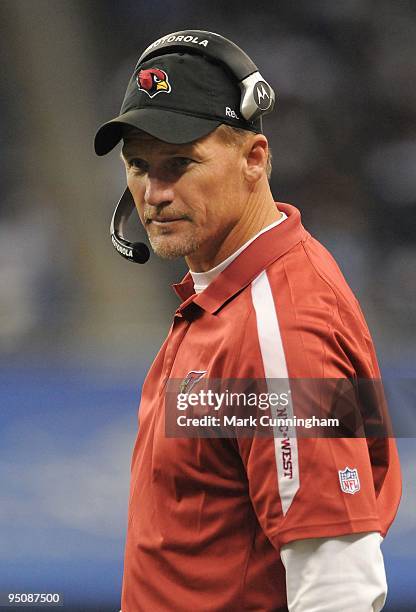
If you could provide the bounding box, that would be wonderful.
[95,36,400,612]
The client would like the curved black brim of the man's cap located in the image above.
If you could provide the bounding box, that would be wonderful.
[94,108,221,155]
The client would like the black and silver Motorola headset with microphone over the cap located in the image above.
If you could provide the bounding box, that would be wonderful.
[110,30,275,263]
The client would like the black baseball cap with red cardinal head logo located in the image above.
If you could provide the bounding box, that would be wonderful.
[94,53,262,155]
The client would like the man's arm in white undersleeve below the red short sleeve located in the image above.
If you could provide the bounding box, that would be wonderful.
[280,532,387,612]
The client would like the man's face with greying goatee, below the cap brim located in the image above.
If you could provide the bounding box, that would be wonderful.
[122,130,249,263]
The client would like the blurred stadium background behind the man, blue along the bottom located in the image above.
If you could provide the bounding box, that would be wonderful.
[0,0,416,612]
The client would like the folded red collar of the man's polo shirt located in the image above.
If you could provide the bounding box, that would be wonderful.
[172,202,309,314]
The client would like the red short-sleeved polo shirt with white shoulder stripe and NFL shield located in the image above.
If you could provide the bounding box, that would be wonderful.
[122,203,401,612]
